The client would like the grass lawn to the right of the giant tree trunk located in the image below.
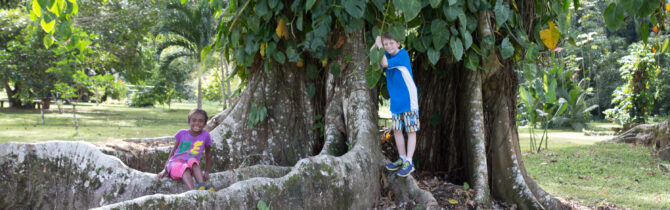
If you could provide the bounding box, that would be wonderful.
[519,124,670,209]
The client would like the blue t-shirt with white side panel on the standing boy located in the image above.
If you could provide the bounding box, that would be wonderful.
[385,49,419,114]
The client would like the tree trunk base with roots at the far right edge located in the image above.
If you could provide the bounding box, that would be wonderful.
[610,120,670,160]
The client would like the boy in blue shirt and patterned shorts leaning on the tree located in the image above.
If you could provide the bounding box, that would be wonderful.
[373,33,420,177]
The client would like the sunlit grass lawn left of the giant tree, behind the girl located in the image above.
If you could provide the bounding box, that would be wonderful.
[0,102,226,143]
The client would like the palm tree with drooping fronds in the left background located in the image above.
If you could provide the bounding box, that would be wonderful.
[154,0,216,109]
